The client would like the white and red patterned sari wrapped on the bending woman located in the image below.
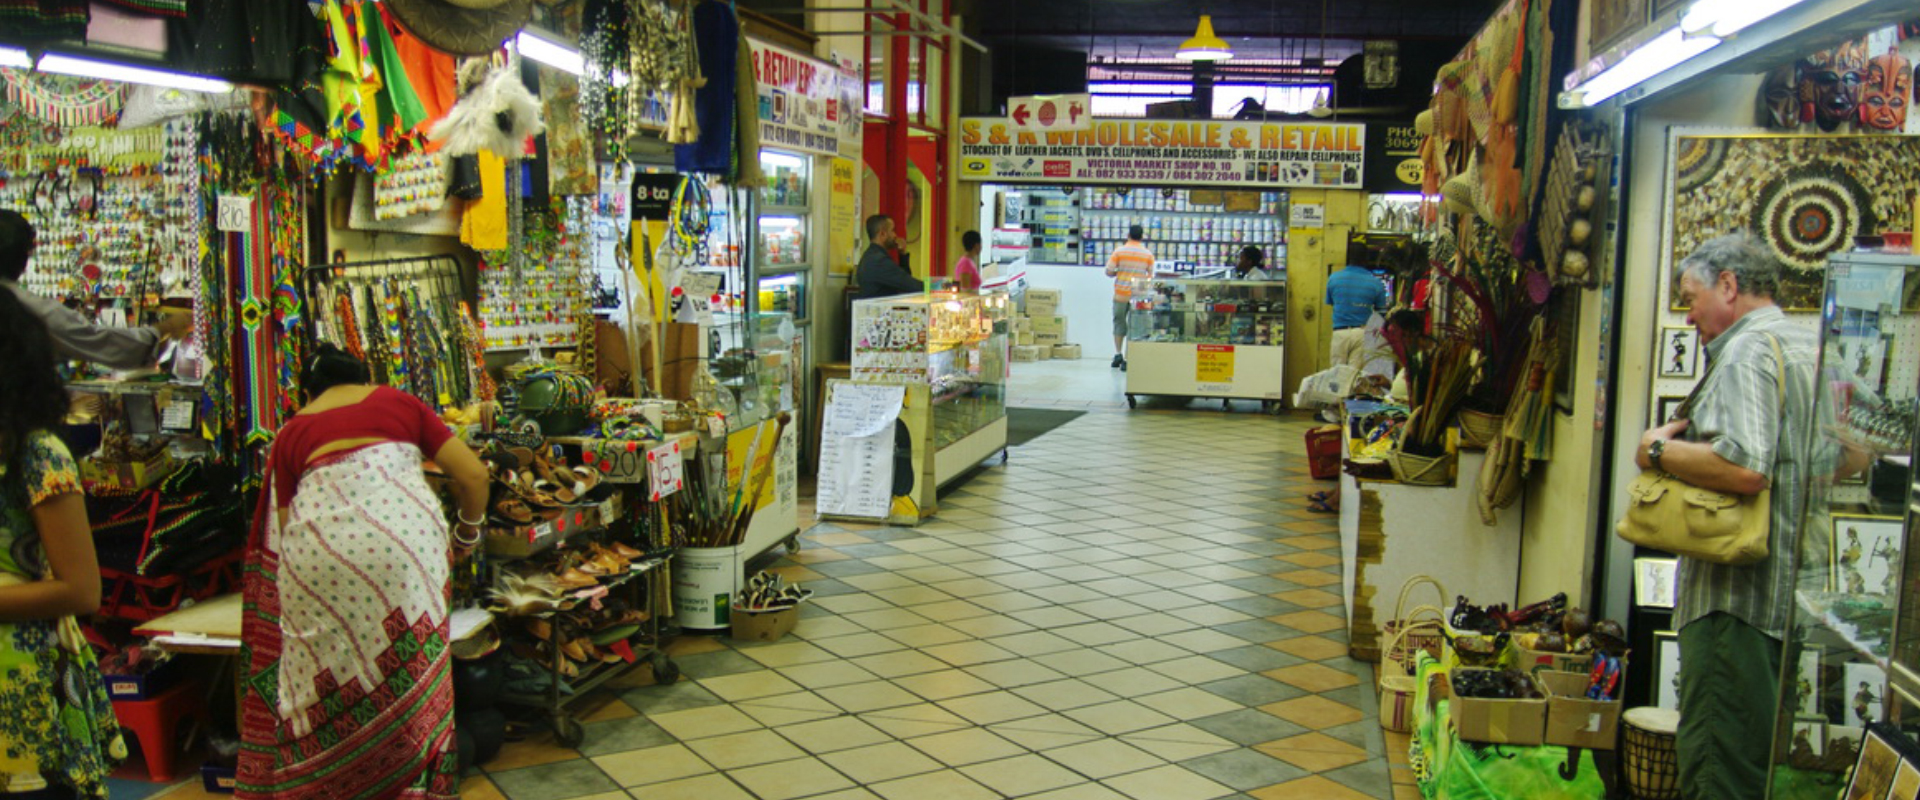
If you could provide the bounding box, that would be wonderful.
[236,443,459,800]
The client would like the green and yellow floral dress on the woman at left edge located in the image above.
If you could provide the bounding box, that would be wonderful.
[0,432,127,800]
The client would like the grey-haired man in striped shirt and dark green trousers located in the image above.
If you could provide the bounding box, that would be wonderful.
[1636,234,1820,800]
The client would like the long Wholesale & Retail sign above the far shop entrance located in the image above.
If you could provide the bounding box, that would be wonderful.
[960,117,1367,188]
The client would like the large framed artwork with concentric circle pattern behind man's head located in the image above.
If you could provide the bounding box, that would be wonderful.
[1658,134,1920,311]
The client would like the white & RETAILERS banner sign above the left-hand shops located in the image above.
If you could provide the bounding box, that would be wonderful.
[747,38,862,155]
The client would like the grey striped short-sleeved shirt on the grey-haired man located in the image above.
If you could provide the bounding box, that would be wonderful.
[1672,305,1826,639]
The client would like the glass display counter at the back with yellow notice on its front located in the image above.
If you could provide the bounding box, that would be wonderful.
[1127,278,1286,407]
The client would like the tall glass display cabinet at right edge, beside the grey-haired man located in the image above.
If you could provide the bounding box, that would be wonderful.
[1766,253,1920,798]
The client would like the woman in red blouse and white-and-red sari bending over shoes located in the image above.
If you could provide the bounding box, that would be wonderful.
[236,345,488,800]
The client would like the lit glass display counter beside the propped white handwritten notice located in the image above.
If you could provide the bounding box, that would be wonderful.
[852,290,1012,524]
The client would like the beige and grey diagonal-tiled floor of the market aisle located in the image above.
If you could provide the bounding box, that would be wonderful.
[165,408,1419,800]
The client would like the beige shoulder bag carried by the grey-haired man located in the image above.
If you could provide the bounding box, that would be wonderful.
[1615,334,1788,564]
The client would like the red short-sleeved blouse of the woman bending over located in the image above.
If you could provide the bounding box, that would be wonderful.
[273,386,453,508]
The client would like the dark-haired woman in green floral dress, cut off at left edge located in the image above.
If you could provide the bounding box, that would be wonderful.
[0,283,127,800]
